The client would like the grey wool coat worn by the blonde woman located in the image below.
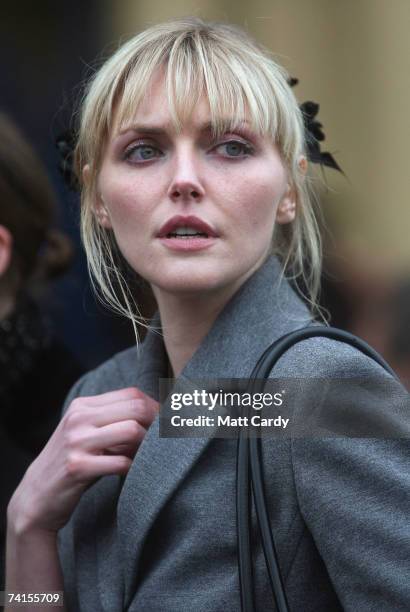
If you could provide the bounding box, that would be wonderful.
[59,257,410,612]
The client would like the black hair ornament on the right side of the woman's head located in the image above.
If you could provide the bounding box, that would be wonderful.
[288,78,343,174]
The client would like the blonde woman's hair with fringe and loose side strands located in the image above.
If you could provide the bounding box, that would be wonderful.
[75,18,321,338]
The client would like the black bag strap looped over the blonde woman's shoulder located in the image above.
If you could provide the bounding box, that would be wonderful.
[236,325,397,612]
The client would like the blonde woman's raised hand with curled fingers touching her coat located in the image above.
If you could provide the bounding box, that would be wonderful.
[8,387,159,533]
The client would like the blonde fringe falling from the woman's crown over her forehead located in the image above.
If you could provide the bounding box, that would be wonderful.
[96,24,299,149]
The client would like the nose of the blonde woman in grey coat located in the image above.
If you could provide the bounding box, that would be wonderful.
[168,151,204,202]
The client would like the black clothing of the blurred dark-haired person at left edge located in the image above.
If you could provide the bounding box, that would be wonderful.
[0,298,83,590]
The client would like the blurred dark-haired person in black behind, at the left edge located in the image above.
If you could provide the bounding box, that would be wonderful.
[0,113,82,588]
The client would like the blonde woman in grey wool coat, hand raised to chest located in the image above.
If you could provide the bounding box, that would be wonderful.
[7,19,410,612]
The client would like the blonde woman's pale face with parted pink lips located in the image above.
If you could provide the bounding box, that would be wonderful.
[96,71,295,297]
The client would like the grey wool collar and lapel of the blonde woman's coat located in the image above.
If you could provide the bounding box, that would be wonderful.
[111,256,311,605]
